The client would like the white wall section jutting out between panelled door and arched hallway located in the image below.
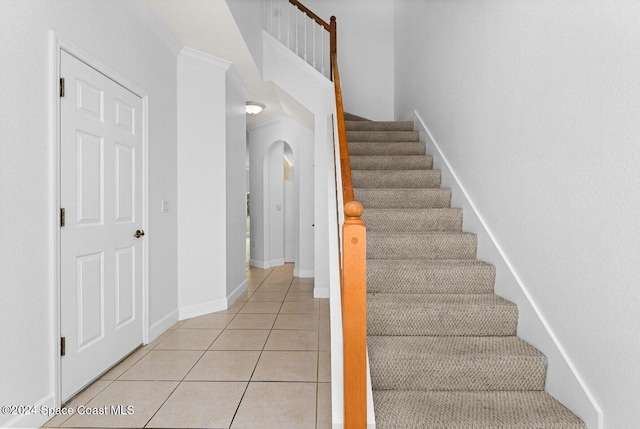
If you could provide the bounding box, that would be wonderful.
[178,48,246,319]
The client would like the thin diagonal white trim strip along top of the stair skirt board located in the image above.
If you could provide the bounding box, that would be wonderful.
[413,111,604,429]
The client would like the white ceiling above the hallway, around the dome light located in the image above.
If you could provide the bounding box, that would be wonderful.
[145,0,313,129]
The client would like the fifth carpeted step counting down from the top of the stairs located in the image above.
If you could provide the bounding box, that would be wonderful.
[351,170,441,188]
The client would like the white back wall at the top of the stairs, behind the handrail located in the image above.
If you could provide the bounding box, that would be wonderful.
[303,0,395,121]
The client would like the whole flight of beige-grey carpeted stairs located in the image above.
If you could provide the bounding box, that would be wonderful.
[347,116,584,429]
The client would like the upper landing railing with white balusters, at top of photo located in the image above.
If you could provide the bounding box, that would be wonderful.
[263,0,331,79]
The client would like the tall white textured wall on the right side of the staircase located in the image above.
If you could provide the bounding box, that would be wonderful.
[395,0,640,428]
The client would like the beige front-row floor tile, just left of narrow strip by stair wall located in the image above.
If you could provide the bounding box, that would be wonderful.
[231,382,316,429]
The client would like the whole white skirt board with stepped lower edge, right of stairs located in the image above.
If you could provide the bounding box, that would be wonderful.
[409,111,603,429]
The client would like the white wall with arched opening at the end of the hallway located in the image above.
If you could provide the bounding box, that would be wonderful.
[249,117,314,277]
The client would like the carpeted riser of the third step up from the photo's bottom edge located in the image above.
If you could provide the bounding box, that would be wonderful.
[367,302,518,336]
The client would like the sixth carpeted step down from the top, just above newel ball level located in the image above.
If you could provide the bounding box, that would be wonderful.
[353,187,451,209]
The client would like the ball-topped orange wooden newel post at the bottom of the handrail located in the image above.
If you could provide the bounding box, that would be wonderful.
[342,201,367,429]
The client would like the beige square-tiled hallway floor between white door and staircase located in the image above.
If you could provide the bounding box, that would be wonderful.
[45,264,331,429]
